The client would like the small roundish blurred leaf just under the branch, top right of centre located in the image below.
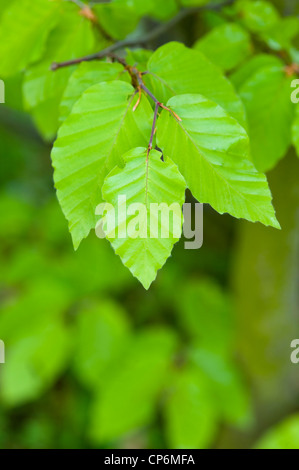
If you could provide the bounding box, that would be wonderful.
[194,23,252,70]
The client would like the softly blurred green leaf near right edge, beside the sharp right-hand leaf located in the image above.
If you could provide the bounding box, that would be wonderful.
[239,62,294,171]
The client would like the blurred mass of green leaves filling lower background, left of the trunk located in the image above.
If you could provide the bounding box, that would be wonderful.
[0,185,249,448]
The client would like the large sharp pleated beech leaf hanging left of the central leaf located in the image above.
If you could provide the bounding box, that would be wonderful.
[52,81,153,248]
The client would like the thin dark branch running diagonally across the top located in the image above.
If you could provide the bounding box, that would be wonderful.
[51,0,235,71]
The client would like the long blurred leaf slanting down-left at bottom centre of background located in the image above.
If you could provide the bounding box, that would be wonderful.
[90,328,176,443]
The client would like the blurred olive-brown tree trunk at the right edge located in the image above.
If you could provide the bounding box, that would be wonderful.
[232,152,299,437]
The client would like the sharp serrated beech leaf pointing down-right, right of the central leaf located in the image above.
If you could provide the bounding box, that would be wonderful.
[157,95,279,228]
